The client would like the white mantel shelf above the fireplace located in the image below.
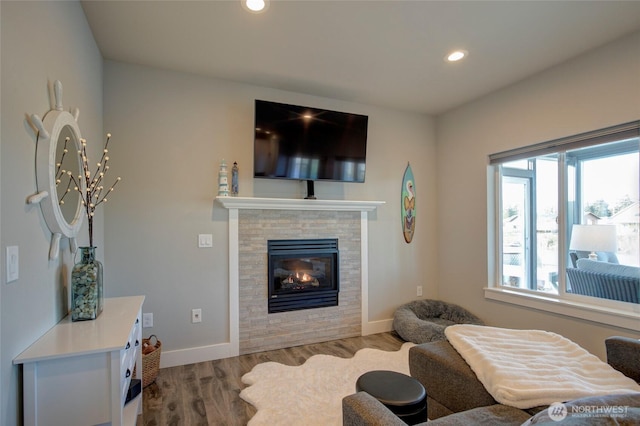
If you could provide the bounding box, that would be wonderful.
[216,197,385,212]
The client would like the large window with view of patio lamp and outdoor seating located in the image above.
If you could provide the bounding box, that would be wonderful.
[489,121,640,326]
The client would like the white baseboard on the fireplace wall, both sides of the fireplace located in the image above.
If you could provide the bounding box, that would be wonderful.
[160,319,393,368]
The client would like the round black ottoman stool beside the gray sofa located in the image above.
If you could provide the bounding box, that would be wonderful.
[356,370,427,425]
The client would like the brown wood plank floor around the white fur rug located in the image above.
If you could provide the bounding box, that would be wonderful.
[138,332,404,426]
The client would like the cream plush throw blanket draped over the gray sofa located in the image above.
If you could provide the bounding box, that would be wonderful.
[445,324,640,409]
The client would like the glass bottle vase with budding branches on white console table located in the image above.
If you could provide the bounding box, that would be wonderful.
[69,133,121,321]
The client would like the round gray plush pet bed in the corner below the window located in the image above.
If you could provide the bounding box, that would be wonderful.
[393,299,484,344]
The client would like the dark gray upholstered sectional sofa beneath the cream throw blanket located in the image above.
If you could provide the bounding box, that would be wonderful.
[342,337,640,426]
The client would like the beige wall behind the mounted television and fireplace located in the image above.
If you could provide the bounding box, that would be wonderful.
[104,61,437,362]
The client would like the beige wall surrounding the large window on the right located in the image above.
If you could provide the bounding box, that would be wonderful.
[437,33,640,356]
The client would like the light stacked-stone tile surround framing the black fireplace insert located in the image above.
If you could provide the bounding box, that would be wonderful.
[238,210,362,354]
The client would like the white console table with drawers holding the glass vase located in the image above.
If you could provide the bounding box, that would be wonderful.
[13,296,144,426]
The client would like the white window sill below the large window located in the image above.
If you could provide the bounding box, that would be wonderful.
[484,287,640,331]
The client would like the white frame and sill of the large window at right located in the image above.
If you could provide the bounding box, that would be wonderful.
[484,120,640,331]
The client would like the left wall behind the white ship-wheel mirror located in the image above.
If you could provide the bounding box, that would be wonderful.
[0,1,104,425]
